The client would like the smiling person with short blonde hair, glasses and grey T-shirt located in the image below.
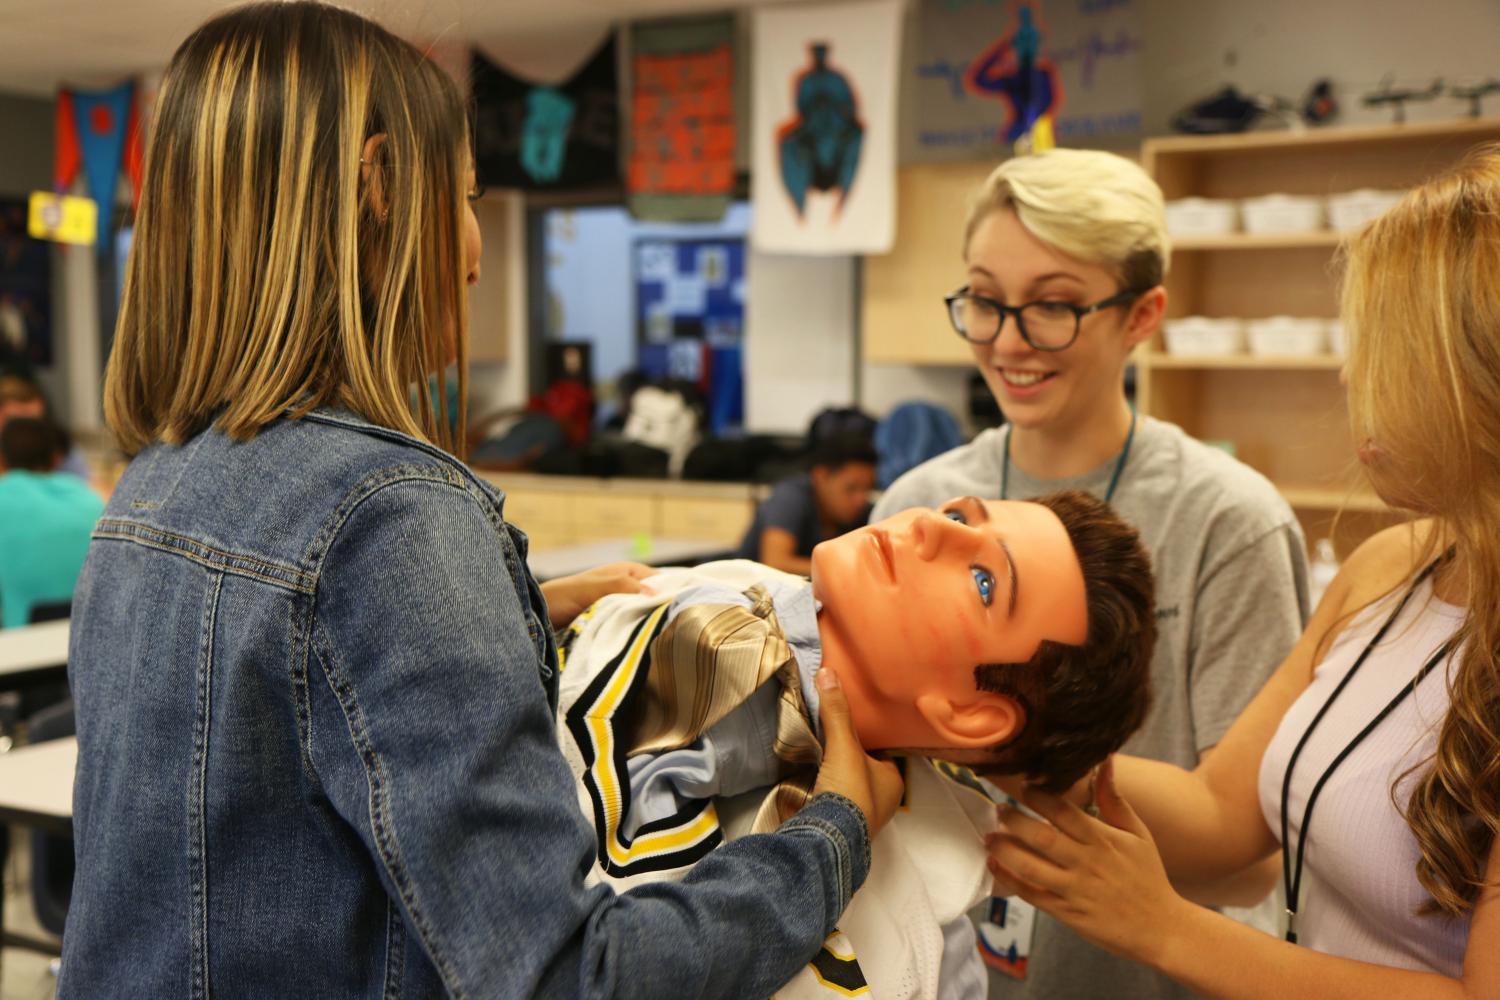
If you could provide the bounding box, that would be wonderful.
[872,150,1307,1000]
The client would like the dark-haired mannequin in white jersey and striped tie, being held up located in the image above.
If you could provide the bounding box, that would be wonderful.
[558,495,1151,1000]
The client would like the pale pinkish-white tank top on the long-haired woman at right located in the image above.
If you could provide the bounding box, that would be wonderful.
[1260,580,1469,978]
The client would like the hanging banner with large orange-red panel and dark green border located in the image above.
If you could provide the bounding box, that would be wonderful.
[626,15,737,222]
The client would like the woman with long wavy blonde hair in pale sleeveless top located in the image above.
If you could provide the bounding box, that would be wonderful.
[992,145,1500,1000]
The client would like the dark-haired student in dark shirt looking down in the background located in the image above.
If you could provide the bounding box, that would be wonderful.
[735,432,878,576]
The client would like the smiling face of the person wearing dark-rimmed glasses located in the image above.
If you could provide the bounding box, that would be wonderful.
[966,208,1154,430]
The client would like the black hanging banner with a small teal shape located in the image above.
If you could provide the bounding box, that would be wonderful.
[473,33,620,190]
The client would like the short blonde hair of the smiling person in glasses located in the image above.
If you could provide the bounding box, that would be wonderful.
[963,150,1172,291]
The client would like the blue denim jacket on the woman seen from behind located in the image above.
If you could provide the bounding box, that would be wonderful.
[59,411,870,999]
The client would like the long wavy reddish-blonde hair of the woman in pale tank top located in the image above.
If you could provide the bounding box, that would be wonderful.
[1343,144,1500,916]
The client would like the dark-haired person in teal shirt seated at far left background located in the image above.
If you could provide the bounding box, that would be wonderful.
[0,418,104,628]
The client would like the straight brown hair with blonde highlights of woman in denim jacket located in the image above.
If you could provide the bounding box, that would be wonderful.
[105,1,468,454]
